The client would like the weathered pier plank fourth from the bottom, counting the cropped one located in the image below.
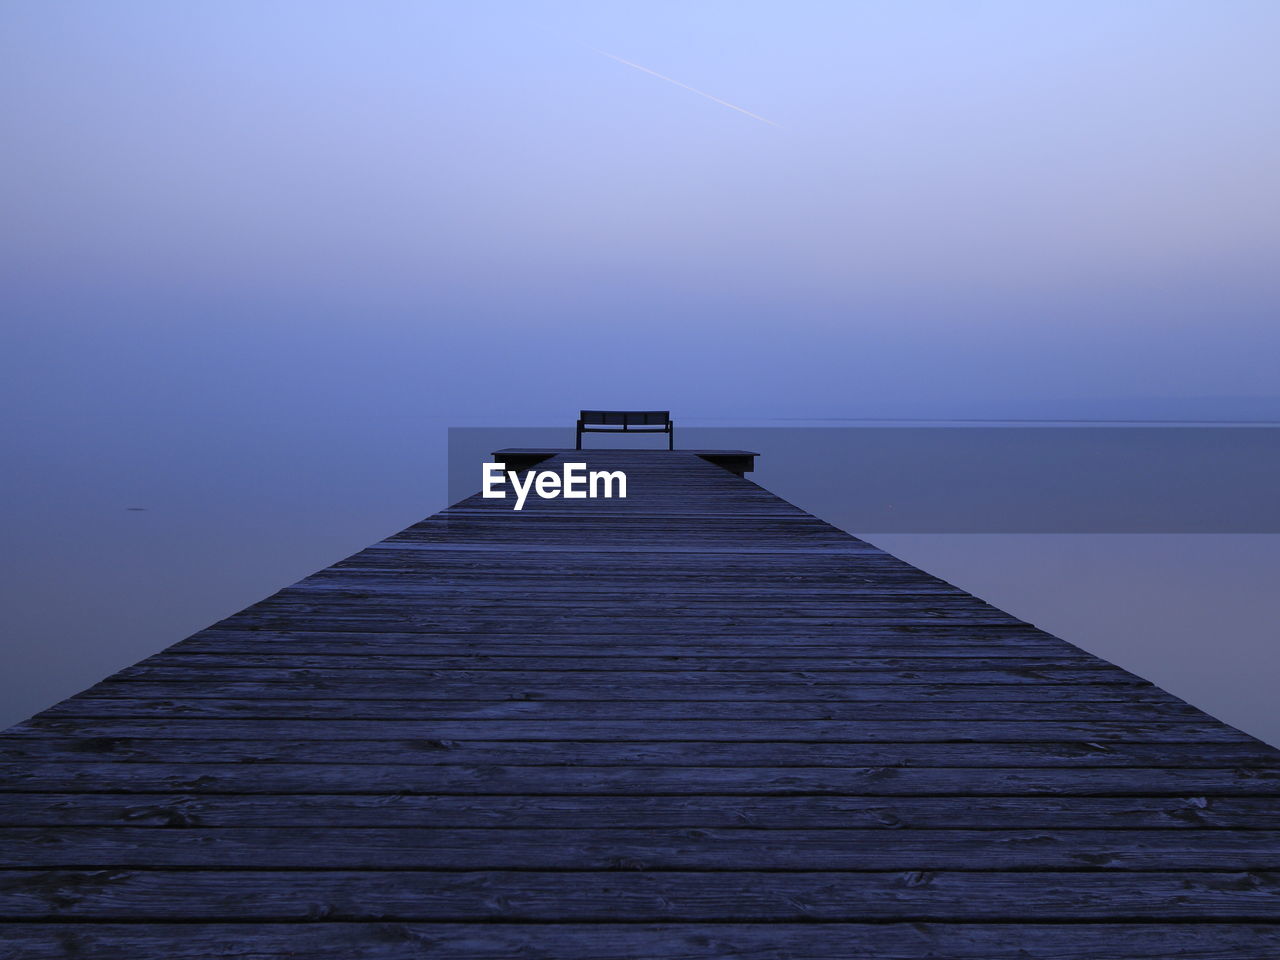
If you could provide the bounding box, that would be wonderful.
[0,791,1280,836]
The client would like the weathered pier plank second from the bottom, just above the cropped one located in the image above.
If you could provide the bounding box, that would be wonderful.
[0,869,1280,923]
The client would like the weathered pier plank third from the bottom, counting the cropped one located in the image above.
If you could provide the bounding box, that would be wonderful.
[0,827,1280,872]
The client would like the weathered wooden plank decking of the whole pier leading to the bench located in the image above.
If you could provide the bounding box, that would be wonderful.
[0,451,1280,960]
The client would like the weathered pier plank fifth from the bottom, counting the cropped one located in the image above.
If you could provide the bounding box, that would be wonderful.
[0,768,1280,799]
